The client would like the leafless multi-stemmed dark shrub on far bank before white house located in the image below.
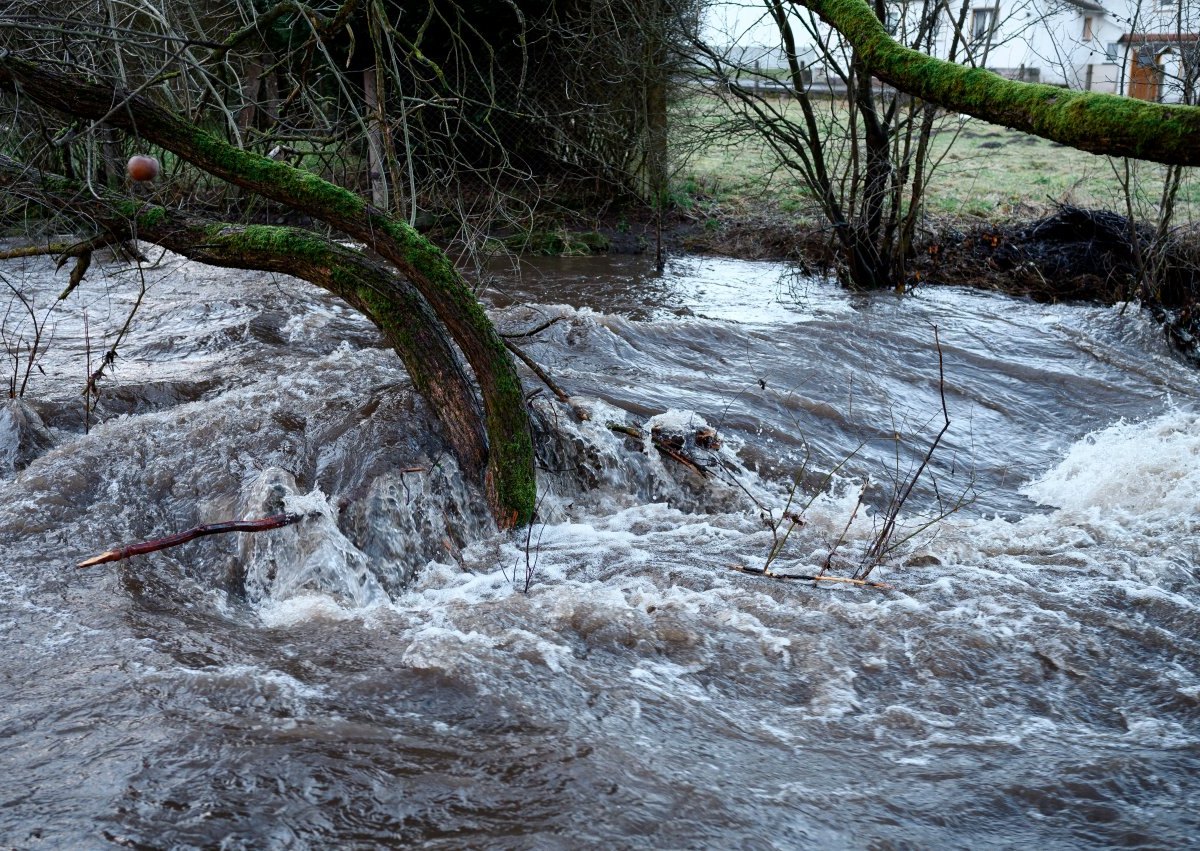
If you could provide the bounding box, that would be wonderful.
[694,0,986,289]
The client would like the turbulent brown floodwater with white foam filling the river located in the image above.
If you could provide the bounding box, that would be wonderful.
[0,247,1200,850]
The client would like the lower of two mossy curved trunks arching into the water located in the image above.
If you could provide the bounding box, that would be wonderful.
[0,154,487,492]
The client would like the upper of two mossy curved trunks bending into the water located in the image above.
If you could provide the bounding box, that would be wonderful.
[0,54,536,527]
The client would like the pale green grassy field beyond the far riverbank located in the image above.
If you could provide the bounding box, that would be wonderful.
[676,94,1200,224]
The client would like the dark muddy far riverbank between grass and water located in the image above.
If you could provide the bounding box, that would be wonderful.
[549,203,1200,365]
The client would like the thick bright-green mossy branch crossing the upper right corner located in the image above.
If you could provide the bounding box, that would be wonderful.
[791,0,1200,166]
